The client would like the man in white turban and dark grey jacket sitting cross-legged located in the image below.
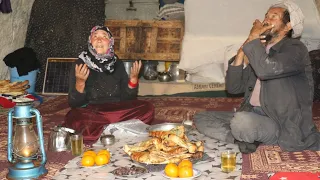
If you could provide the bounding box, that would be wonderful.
[194,0,320,153]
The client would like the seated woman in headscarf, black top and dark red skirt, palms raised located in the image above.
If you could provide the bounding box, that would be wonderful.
[64,26,154,141]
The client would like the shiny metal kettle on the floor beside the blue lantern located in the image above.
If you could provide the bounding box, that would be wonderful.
[48,126,75,152]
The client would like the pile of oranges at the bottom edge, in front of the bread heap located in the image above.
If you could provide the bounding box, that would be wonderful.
[164,159,193,178]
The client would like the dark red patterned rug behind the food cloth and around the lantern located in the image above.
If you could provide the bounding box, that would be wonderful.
[0,96,241,179]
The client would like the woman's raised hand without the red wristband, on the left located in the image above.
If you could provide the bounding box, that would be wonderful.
[75,64,90,93]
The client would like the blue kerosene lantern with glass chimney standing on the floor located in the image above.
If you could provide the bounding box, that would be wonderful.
[7,98,48,180]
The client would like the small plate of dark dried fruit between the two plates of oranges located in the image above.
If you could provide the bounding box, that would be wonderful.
[111,166,148,178]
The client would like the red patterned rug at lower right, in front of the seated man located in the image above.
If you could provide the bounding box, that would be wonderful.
[241,102,320,180]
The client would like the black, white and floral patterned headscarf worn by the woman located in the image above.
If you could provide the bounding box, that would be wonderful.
[79,26,117,73]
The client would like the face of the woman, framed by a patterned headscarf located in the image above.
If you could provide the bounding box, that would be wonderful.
[90,30,110,54]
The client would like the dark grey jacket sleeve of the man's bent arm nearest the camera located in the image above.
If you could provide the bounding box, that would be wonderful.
[243,39,308,80]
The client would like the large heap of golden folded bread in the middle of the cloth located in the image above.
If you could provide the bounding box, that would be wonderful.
[123,125,204,165]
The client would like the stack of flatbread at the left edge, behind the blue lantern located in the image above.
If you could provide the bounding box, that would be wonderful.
[0,80,30,96]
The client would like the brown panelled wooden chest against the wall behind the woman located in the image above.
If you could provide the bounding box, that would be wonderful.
[105,20,184,61]
